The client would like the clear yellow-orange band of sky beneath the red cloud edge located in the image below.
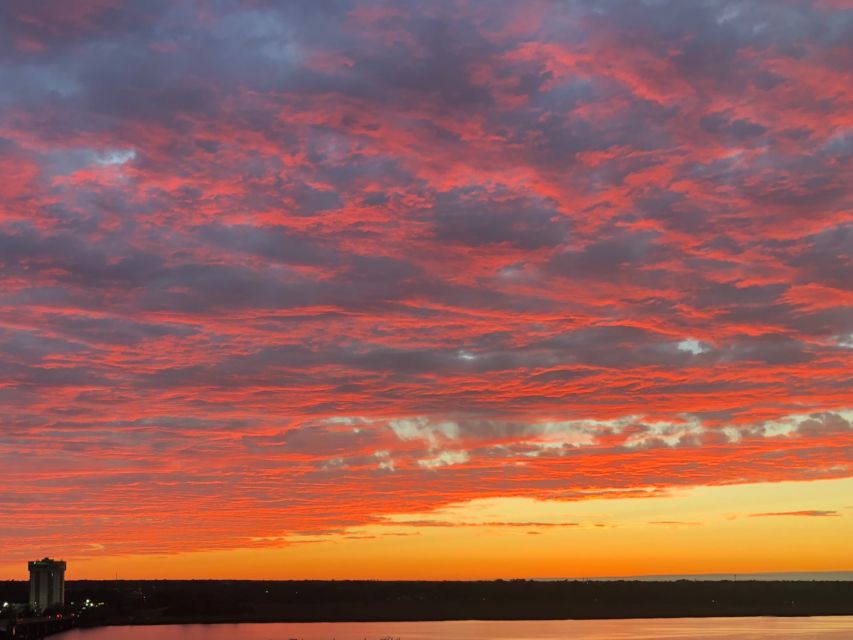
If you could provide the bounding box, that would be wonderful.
[0,479,853,580]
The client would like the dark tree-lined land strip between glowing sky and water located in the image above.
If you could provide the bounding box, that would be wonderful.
[5,580,853,626]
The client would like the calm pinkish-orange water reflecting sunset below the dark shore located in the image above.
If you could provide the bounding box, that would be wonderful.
[54,616,853,640]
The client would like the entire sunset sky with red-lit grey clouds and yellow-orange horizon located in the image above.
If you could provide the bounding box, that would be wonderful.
[0,0,853,579]
